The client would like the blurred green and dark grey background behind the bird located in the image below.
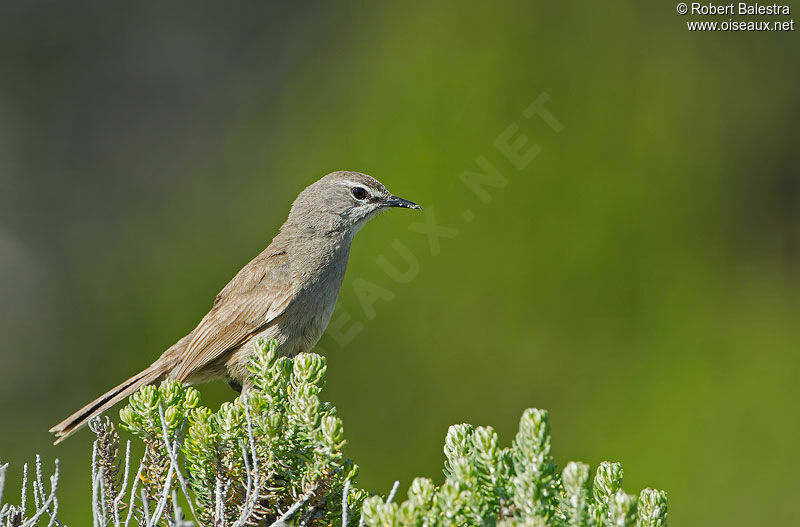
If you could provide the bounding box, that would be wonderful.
[0,0,800,526]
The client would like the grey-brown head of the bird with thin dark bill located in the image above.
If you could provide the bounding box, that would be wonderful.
[287,170,422,234]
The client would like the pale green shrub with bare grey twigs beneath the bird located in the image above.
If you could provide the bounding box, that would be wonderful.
[0,341,667,527]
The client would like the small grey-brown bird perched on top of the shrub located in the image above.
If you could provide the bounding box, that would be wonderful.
[50,171,422,444]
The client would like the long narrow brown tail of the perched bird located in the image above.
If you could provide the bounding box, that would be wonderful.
[50,357,174,445]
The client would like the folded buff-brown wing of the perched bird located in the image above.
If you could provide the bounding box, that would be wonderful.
[174,249,297,382]
